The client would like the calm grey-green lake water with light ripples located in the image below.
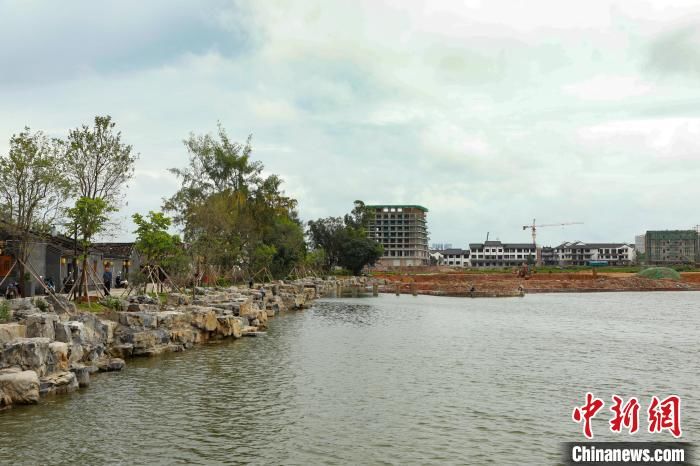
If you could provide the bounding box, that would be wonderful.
[0,293,700,464]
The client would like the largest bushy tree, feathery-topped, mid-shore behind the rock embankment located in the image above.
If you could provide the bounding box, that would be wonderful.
[164,125,304,276]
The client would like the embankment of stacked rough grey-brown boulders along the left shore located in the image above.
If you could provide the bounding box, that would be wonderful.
[0,278,362,410]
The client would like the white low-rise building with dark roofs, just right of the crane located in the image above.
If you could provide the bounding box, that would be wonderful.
[554,241,636,266]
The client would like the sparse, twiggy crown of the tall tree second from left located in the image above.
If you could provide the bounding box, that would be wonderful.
[63,115,138,207]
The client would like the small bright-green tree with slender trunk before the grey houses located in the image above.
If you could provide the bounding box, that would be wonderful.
[66,196,116,296]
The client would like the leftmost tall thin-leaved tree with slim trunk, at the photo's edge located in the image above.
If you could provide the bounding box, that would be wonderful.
[0,127,68,294]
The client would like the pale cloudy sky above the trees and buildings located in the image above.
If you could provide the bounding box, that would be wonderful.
[0,0,700,247]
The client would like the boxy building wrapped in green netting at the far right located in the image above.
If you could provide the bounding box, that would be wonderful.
[645,230,700,264]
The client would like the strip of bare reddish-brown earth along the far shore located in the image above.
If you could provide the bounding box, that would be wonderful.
[375,272,700,296]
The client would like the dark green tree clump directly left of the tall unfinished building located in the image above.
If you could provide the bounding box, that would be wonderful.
[309,201,384,275]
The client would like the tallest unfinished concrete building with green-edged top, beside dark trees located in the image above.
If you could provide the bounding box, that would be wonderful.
[367,205,430,267]
